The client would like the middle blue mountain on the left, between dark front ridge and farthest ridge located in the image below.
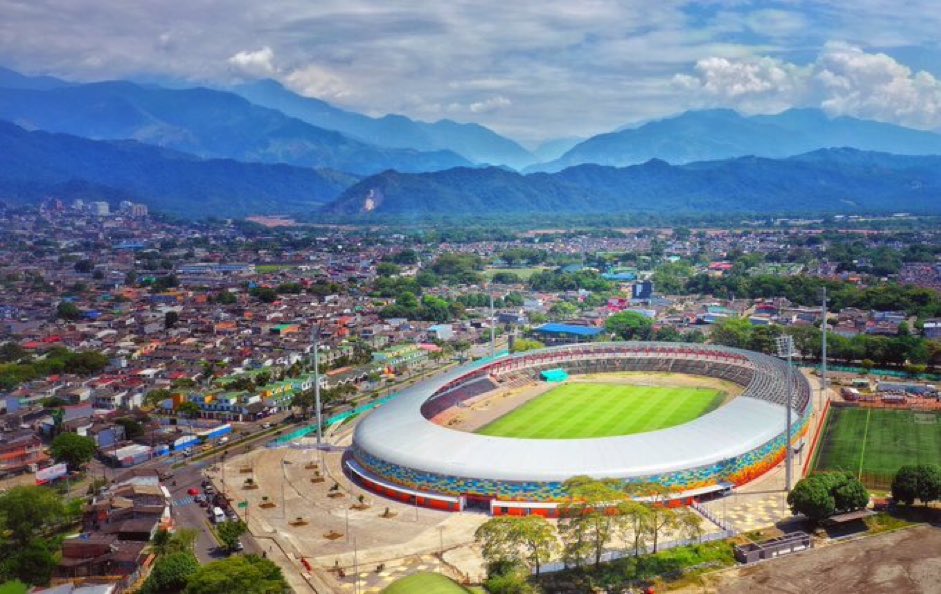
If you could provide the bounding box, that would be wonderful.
[0,75,471,174]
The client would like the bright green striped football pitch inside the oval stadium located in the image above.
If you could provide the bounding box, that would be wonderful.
[477,383,725,439]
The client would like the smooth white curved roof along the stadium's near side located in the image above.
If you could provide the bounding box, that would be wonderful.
[354,346,798,482]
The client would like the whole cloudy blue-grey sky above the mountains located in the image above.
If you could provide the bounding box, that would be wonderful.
[0,0,941,146]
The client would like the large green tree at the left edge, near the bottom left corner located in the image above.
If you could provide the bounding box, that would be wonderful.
[0,485,65,546]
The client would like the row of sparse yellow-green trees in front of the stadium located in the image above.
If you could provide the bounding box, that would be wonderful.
[475,476,703,581]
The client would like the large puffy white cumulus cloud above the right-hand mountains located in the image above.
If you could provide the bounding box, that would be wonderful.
[673,42,941,129]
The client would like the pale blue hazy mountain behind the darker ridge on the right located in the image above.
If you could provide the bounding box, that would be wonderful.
[526,109,941,171]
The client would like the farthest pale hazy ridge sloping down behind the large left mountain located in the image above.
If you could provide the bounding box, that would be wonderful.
[232,79,536,168]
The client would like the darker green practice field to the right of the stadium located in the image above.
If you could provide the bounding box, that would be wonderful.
[815,408,941,488]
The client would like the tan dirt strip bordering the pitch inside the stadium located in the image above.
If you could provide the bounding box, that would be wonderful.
[435,372,744,432]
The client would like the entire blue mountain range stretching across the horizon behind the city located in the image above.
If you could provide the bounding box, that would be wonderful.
[0,68,941,218]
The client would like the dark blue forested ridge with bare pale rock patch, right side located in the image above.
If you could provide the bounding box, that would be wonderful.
[325,148,941,218]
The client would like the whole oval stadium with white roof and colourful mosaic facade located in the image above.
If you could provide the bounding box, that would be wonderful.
[344,342,811,515]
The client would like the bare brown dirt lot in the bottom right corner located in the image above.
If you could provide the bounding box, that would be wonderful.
[675,526,941,594]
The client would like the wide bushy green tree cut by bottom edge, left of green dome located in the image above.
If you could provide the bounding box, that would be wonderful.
[183,555,289,594]
